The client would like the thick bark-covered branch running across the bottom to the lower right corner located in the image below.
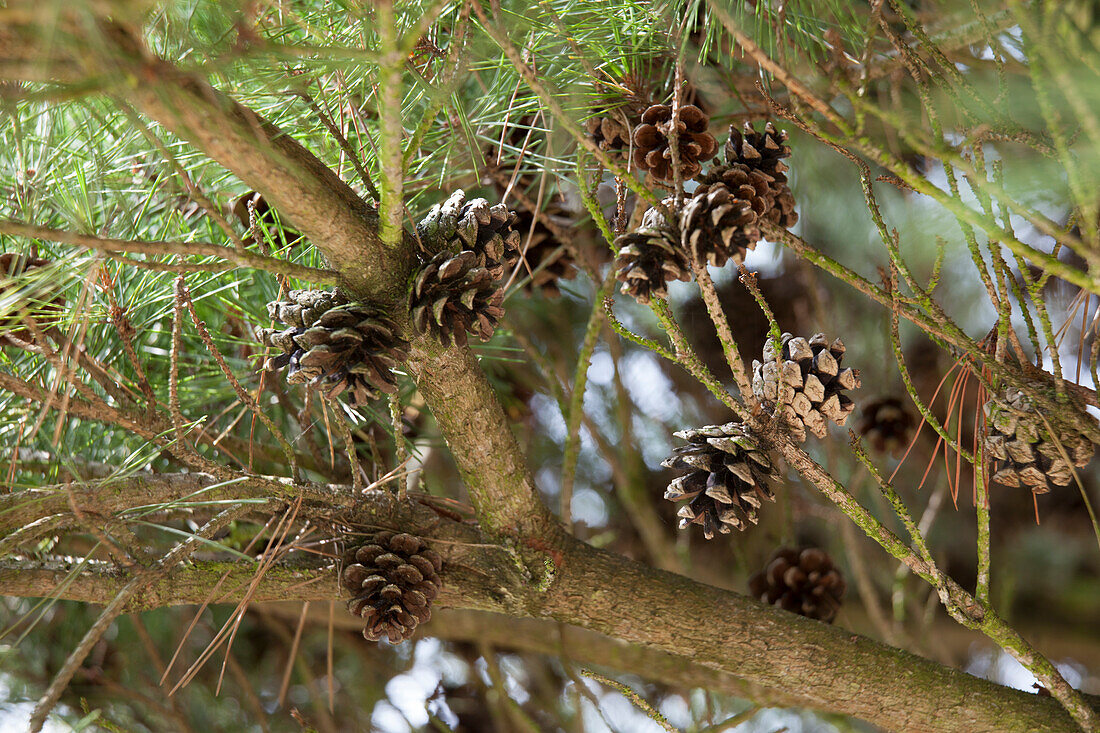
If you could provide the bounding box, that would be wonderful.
[0,479,1086,732]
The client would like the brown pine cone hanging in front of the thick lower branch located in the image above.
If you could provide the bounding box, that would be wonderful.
[340,532,443,644]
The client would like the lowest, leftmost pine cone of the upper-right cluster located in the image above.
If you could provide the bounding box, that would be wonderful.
[613,209,691,304]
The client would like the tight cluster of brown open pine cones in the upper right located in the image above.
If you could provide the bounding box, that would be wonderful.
[600,115,799,304]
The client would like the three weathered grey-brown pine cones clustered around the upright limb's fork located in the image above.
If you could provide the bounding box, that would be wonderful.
[259,189,519,405]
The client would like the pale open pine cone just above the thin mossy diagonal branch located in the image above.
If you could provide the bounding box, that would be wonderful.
[752,333,860,442]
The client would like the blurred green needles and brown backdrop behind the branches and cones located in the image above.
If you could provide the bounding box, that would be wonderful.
[0,0,1100,732]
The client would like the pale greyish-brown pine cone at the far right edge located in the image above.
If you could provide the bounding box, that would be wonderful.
[982,389,1093,494]
